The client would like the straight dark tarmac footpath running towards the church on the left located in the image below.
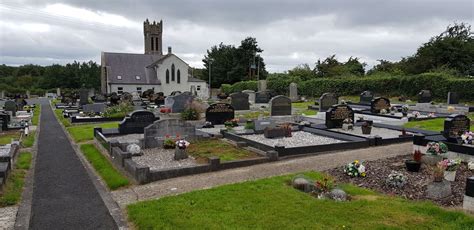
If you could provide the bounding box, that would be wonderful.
[30,104,117,229]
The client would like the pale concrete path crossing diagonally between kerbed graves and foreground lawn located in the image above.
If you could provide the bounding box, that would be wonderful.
[112,143,413,208]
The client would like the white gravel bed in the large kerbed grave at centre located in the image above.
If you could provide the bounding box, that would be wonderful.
[241,131,346,148]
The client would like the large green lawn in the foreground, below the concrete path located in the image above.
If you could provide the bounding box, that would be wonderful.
[127,172,474,229]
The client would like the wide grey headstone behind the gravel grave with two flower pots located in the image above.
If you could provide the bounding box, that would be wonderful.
[144,119,197,148]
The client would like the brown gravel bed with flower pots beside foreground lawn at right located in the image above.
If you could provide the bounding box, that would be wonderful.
[326,155,474,207]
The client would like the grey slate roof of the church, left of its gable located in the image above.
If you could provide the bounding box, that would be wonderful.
[102,52,164,85]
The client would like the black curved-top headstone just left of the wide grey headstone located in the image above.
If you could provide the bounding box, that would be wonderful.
[119,110,159,134]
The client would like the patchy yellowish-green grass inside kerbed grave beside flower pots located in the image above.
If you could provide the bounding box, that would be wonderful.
[187,139,258,163]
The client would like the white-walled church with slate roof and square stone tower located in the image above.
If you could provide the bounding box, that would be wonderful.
[101,19,209,98]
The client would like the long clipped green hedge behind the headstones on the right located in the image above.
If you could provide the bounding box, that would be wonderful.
[222,73,474,100]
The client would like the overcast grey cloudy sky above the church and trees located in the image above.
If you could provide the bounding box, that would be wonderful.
[0,0,474,72]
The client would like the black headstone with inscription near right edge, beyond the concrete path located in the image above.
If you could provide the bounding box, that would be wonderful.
[443,114,471,142]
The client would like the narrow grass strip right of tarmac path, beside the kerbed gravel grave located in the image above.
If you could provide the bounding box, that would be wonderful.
[81,144,130,190]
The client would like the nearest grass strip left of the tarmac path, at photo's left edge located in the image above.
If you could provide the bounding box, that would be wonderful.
[0,152,32,207]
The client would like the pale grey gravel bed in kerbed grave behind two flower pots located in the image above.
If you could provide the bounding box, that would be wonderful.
[132,148,199,170]
